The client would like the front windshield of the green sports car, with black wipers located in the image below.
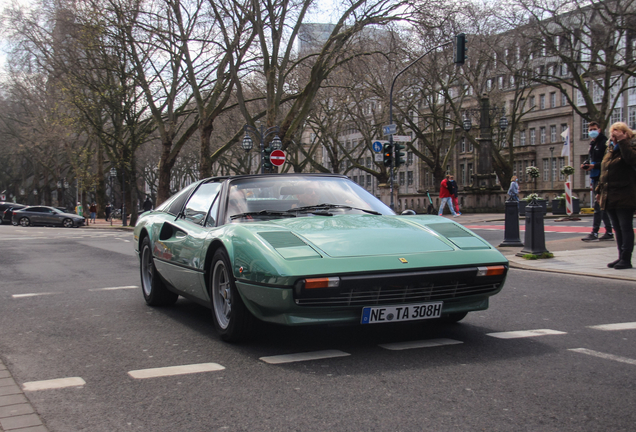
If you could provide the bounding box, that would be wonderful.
[227,175,395,222]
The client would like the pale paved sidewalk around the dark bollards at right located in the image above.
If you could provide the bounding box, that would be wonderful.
[453,213,636,282]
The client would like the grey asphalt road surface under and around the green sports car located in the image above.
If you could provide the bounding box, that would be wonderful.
[0,226,636,432]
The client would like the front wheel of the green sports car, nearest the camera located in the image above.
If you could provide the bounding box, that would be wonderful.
[210,249,255,342]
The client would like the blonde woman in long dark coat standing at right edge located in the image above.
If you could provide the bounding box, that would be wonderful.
[597,122,636,270]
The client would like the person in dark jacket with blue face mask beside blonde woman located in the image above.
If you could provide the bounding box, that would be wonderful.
[581,121,614,241]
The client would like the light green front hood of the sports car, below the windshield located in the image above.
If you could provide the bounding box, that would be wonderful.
[259,215,491,258]
